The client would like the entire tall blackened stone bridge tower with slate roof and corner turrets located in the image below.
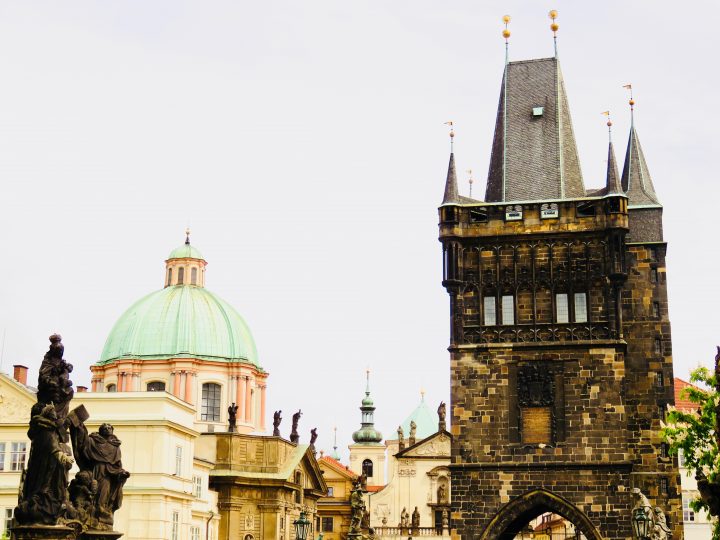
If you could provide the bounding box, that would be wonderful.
[439,40,682,540]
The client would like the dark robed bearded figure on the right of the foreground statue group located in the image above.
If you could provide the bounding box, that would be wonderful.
[70,414,130,531]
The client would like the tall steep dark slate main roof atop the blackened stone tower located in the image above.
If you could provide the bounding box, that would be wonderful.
[485,58,585,202]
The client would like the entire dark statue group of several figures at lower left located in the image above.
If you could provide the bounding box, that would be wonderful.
[13,334,130,540]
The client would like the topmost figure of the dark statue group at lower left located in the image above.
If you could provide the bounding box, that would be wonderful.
[37,334,74,442]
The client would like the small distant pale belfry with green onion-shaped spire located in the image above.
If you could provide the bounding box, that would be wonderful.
[348,369,385,486]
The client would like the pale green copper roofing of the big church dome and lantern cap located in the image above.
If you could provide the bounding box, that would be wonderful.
[98,284,259,367]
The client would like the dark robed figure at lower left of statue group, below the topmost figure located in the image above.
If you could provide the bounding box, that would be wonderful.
[15,402,73,525]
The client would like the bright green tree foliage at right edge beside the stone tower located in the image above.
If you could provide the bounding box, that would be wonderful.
[662,367,720,540]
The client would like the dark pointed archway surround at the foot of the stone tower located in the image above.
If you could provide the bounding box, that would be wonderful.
[480,489,603,540]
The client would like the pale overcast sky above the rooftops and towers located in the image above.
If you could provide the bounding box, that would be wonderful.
[0,0,720,460]
